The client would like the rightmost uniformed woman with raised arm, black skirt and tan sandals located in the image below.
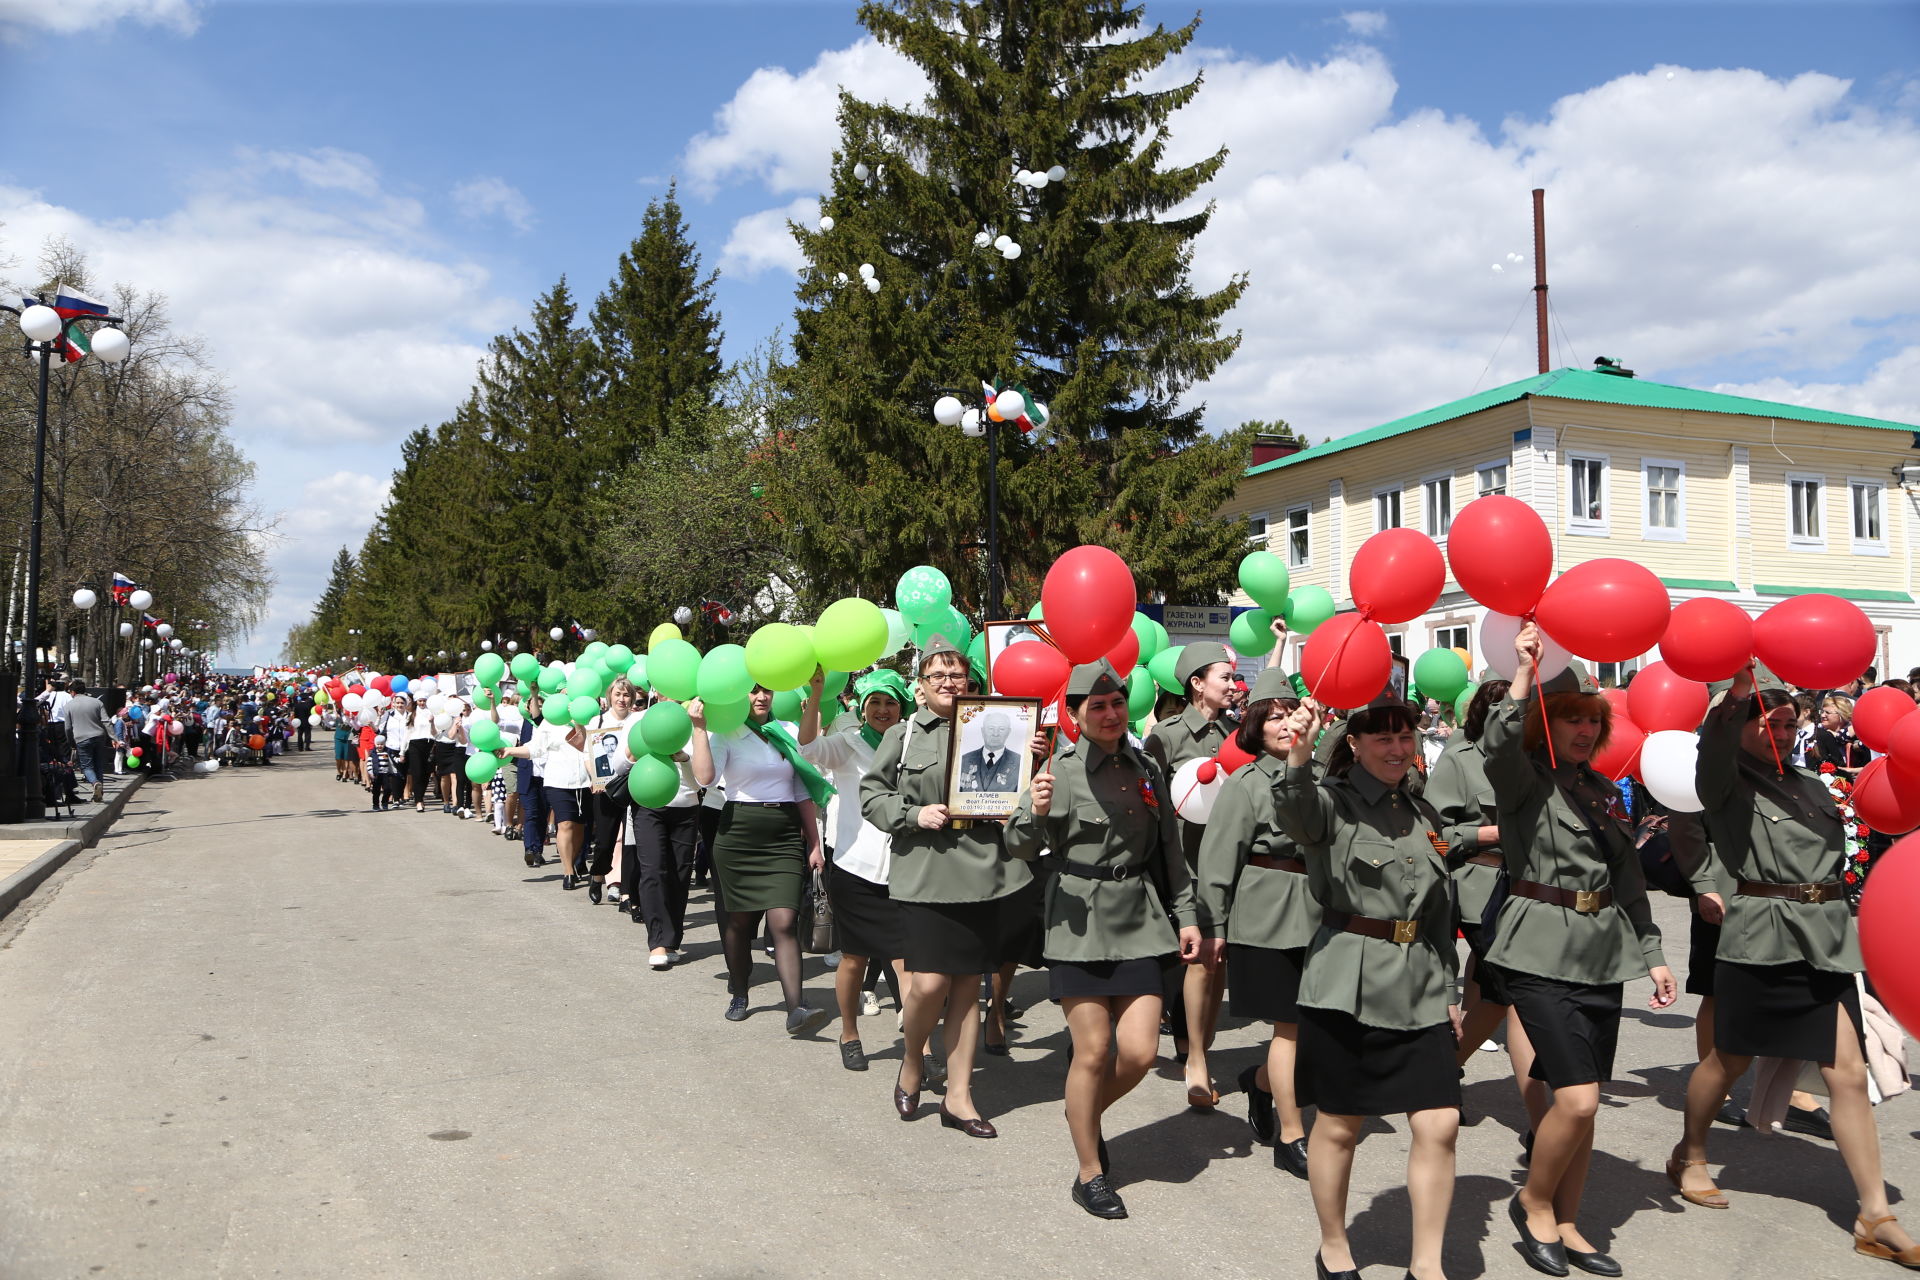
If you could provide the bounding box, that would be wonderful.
[1667,672,1920,1268]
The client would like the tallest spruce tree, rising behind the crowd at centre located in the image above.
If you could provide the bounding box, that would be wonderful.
[776,0,1248,606]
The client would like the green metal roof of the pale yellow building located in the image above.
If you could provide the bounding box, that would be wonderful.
[1246,368,1920,476]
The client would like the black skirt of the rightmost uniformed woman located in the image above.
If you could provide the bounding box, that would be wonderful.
[1713,960,1864,1063]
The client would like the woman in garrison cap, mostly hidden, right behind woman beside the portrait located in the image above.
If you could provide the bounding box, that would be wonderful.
[1146,643,1233,1107]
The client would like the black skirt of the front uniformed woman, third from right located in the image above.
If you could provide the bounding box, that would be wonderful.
[1294,1006,1459,1115]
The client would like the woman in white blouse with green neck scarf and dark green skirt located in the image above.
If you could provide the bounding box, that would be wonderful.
[687,685,833,1036]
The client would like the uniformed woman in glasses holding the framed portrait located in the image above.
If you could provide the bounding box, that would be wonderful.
[860,635,1033,1138]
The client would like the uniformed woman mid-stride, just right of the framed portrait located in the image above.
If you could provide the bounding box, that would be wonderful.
[1006,662,1200,1219]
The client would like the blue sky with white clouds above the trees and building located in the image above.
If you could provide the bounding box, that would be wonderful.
[0,0,1920,660]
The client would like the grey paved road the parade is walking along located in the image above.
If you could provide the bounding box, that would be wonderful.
[0,752,1920,1280]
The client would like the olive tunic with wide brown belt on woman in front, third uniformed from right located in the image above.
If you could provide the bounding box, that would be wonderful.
[1275,766,1457,1031]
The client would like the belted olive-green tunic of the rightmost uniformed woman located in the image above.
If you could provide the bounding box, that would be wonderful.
[1697,699,1862,973]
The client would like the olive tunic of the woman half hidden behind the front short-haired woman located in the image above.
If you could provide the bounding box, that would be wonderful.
[1194,754,1319,950]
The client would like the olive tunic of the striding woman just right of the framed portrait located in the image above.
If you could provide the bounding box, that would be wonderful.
[998,737,1194,963]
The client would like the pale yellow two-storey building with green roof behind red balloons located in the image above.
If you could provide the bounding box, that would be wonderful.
[1225,361,1920,681]
